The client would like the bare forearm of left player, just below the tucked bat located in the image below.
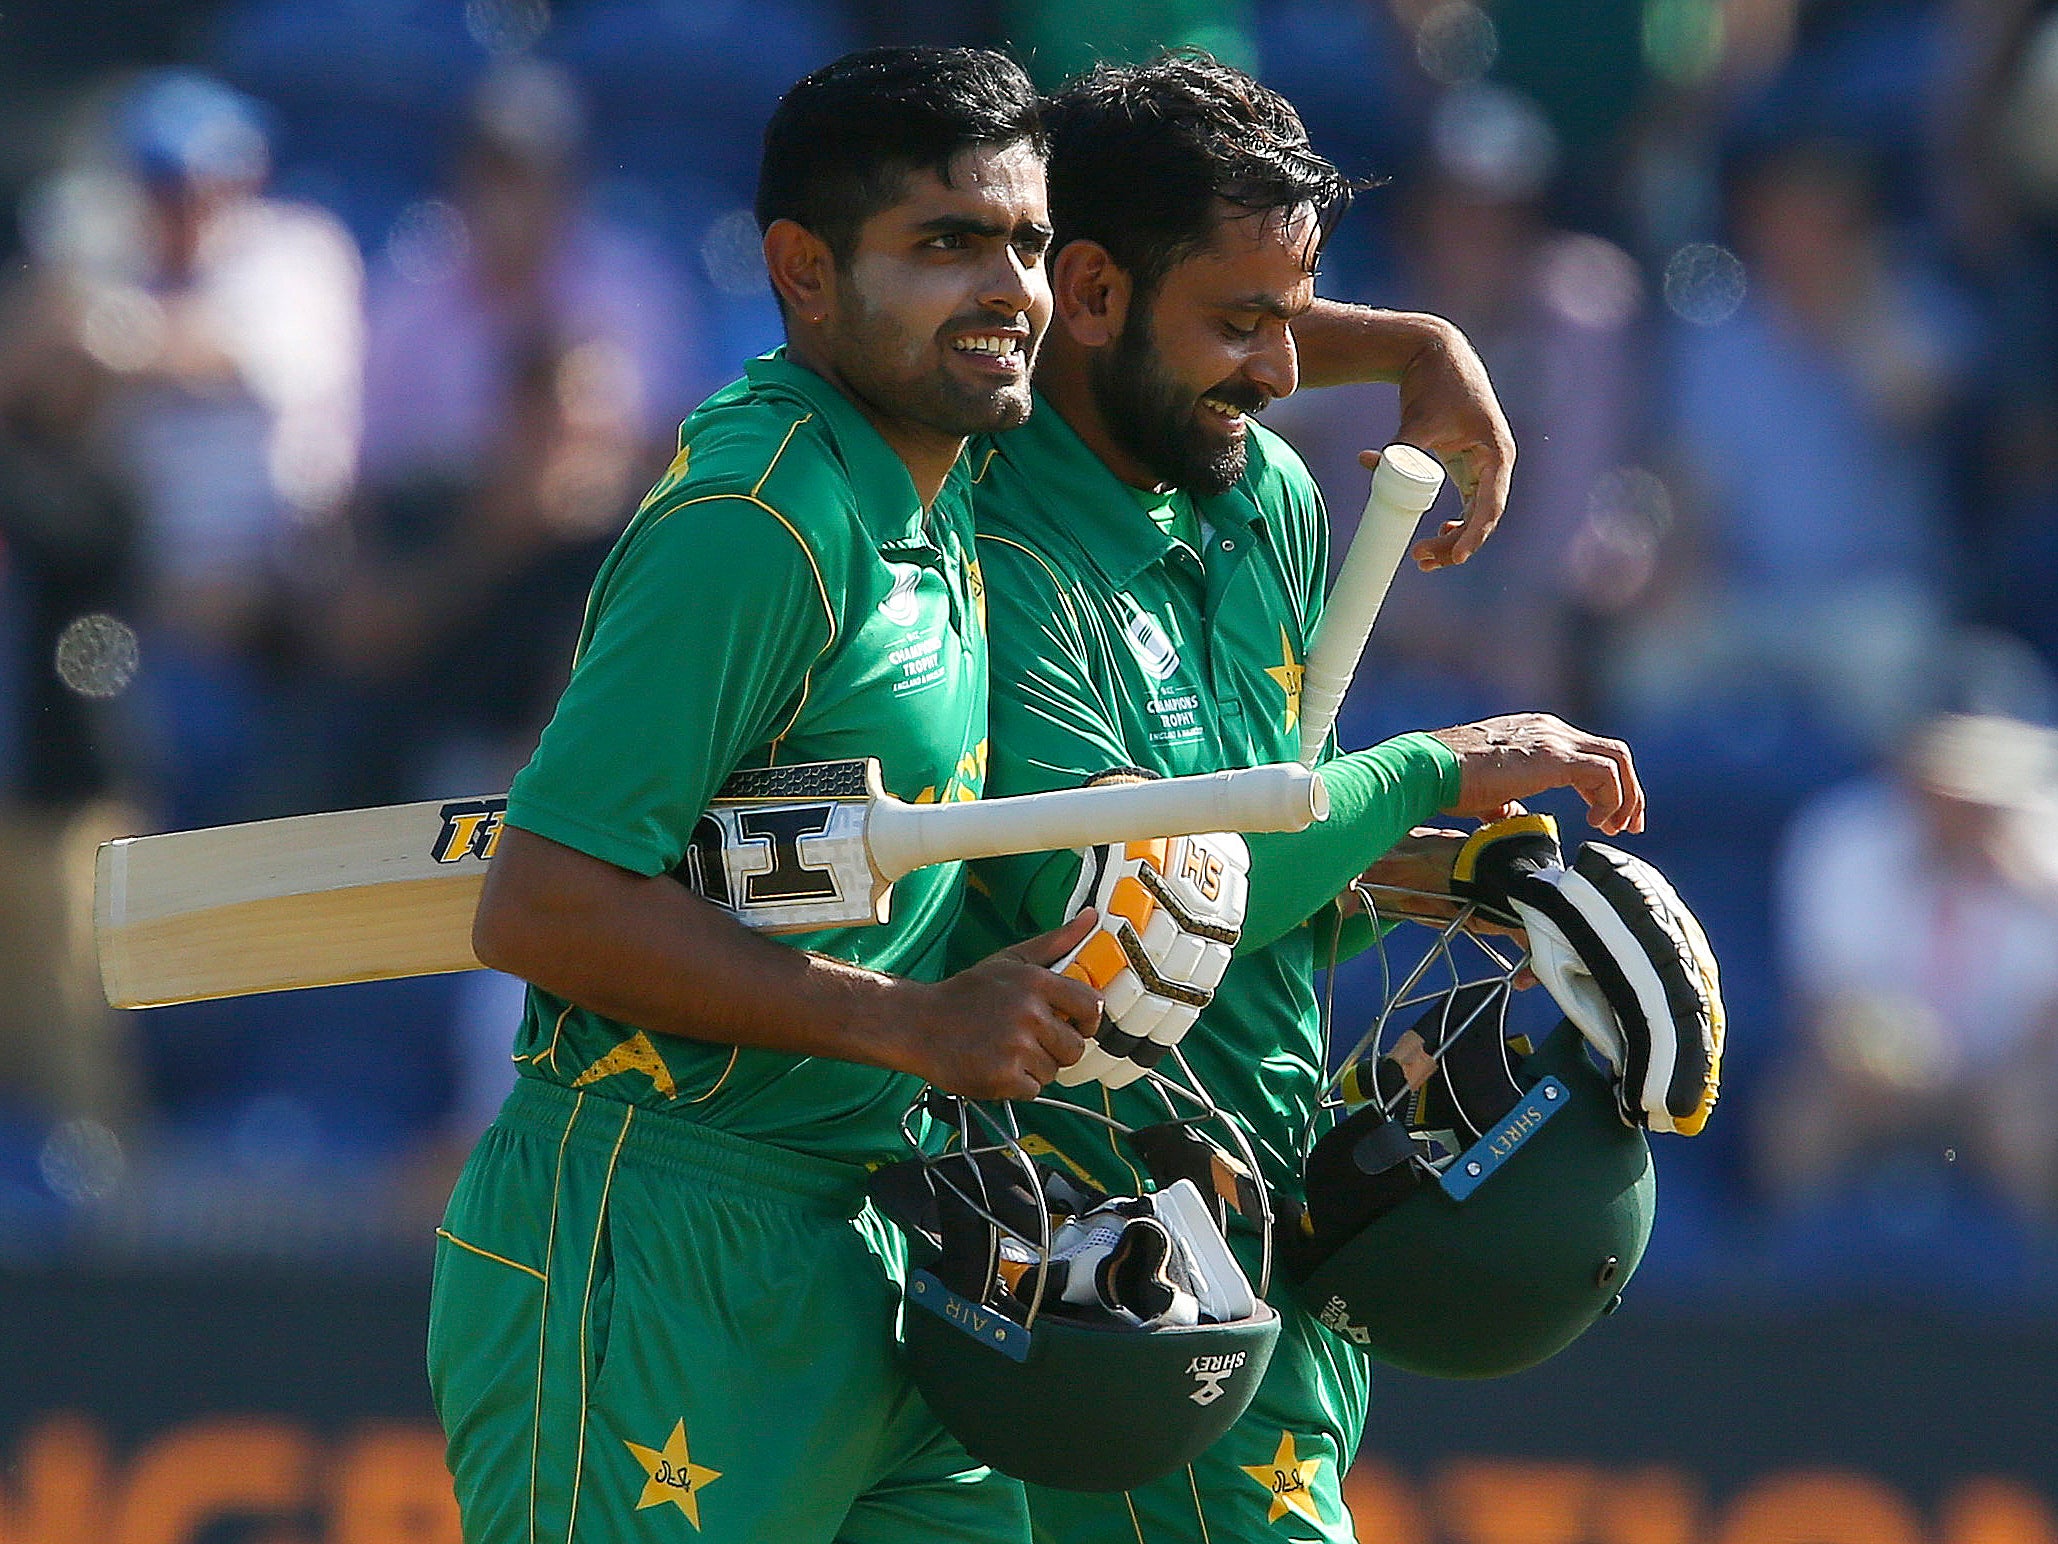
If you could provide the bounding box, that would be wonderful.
[473,826,922,1071]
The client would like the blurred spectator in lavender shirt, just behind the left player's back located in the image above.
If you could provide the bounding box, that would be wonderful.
[331,64,694,803]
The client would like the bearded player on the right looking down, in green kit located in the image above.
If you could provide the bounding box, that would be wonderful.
[959,58,1642,1544]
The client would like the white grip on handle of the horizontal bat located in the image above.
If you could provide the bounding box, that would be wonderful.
[864,762,1329,881]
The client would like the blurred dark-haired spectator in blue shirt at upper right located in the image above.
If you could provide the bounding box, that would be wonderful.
[1616,142,1978,747]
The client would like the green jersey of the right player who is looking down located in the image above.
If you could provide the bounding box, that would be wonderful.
[957,399,1457,1218]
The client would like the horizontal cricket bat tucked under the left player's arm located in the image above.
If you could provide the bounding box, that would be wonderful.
[93,758,1329,1009]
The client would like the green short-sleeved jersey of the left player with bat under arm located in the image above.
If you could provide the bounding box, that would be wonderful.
[493,354,986,1163]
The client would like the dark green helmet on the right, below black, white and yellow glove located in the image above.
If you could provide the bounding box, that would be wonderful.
[1280,896,1657,1377]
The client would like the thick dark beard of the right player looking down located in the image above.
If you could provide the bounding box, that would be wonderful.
[1087,307,1270,494]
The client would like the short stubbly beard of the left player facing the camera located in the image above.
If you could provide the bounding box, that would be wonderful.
[836,292,1039,438]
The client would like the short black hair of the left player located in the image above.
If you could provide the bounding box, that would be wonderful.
[757,47,1048,266]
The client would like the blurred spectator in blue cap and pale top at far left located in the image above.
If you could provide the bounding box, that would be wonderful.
[21,70,360,823]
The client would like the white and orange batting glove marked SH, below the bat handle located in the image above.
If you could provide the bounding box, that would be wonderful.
[1056,832,1251,1089]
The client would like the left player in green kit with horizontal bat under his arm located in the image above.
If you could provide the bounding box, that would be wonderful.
[430,49,1099,1544]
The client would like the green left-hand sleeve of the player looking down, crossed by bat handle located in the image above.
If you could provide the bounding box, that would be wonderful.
[973,535,1136,943]
